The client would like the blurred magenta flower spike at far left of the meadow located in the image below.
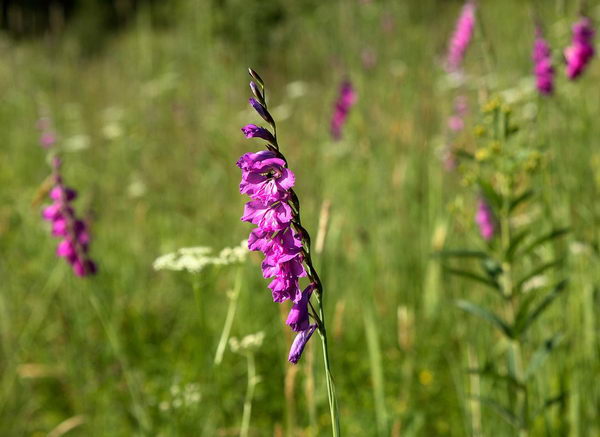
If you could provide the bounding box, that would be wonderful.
[42,158,97,276]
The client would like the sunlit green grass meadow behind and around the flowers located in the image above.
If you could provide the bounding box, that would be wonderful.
[0,0,600,437]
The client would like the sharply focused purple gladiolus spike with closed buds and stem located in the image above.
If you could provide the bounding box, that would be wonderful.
[237,69,340,437]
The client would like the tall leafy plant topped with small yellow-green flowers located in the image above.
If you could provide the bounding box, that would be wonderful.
[438,93,567,436]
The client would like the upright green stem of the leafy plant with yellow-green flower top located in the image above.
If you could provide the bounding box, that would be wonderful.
[500,186,529,437]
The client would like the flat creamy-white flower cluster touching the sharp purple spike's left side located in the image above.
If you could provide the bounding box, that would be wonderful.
[153,240,249,273]
